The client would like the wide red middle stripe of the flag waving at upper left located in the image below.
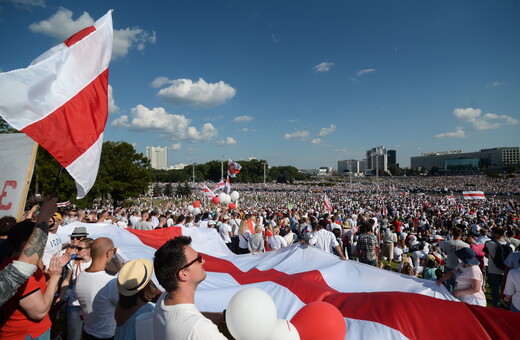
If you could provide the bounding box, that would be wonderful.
[22,69,108,168]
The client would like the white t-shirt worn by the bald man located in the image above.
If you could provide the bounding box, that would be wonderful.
[75,271,119,338]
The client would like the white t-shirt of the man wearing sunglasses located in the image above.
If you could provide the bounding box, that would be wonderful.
[153,293,226,340]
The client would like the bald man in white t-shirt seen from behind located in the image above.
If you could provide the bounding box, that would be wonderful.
[75,237,119,340]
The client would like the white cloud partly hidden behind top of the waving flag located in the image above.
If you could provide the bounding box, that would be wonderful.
[29,7,157,59]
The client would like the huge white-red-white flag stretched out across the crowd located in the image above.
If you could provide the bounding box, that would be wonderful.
[58,222,520,339]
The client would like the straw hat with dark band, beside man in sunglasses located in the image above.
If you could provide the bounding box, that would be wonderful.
[117,259,153,296]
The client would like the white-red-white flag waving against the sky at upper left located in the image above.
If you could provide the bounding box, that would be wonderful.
[0,11,113,198]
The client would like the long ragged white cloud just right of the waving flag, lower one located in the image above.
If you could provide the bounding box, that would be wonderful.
[112,105,217,142]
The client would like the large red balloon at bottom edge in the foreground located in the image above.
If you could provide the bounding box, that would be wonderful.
[291,301,347,340]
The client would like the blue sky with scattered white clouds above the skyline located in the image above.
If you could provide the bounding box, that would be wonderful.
[0,0,520,168]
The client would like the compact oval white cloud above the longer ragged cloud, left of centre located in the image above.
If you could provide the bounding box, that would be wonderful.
[152,77,236,108]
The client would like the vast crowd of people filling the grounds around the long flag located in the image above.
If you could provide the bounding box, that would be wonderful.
[0,177,520,340]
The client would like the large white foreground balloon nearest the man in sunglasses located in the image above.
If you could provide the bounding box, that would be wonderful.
[226,288,277,340]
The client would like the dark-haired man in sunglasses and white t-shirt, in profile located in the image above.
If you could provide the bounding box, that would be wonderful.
[153,236,226,340]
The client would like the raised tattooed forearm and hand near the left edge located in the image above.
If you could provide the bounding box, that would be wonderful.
[18,197,58,265]
